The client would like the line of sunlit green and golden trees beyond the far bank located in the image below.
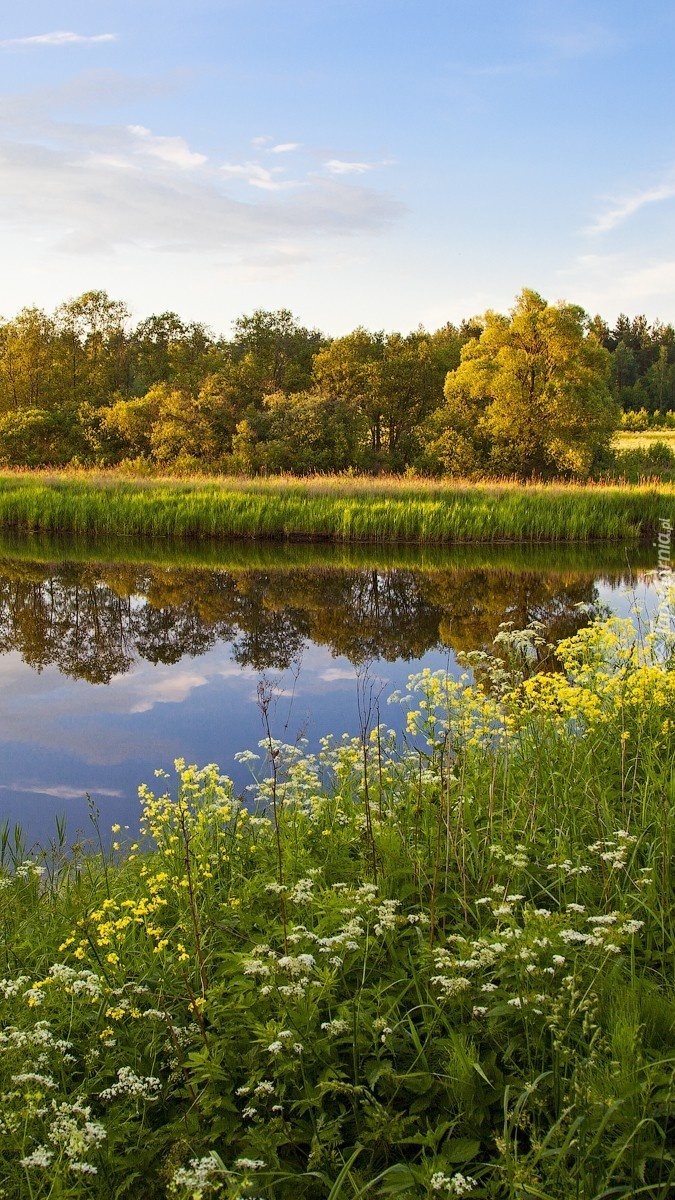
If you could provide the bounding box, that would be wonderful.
[0,289,675,478]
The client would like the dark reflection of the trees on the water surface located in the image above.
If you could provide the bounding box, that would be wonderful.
[0,559,629,683]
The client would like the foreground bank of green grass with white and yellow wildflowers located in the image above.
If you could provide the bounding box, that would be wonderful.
[0,619,675,1200]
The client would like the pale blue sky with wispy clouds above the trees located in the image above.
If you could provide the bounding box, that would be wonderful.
[0,0,675,336]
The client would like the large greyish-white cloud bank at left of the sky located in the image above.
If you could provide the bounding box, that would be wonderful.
[0,81,401,271]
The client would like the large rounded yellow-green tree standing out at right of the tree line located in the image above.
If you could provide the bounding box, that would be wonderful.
[430,289,619,476]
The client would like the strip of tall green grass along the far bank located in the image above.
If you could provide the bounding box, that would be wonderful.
[0,472,675,545]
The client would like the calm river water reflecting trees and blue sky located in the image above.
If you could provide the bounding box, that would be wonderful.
[0,538,657,840]
